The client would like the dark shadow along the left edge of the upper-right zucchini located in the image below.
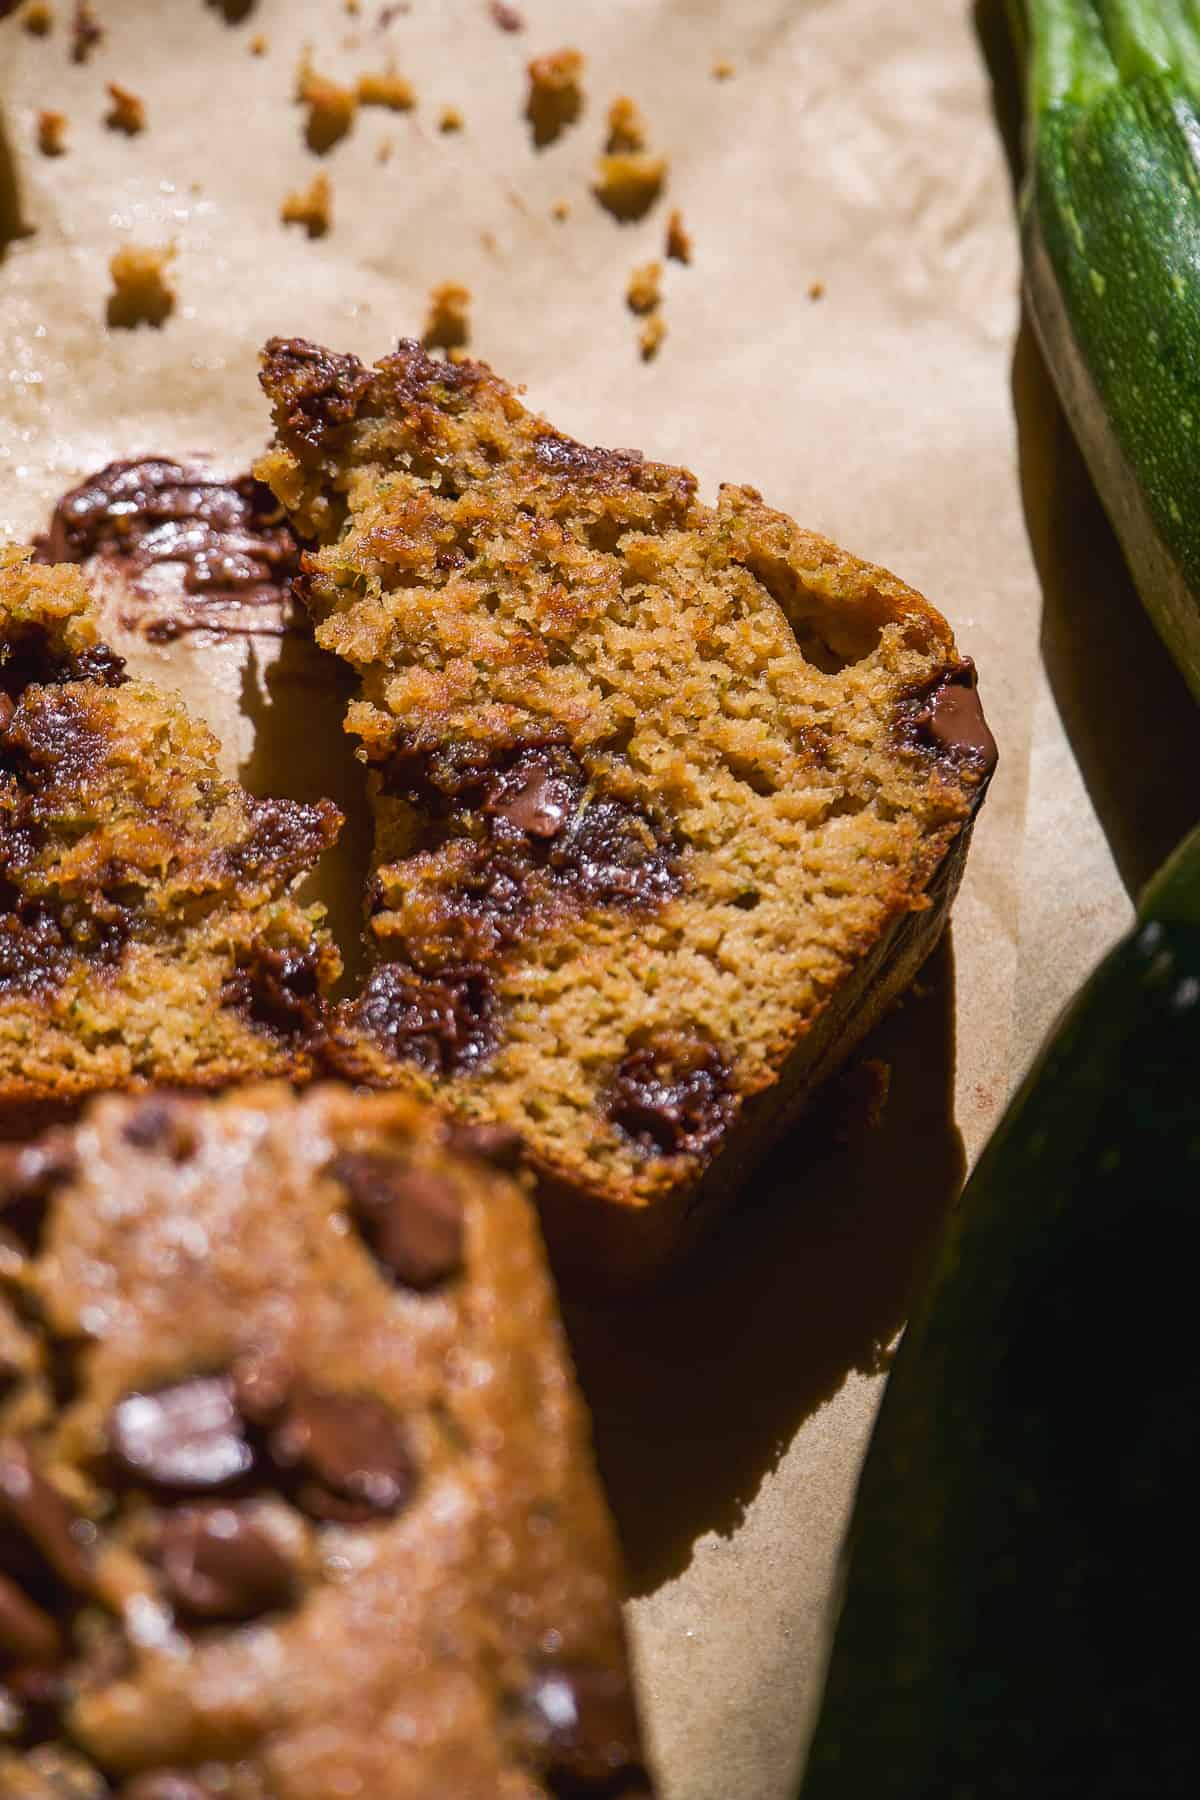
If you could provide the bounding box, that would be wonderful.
[975,0,1200,896]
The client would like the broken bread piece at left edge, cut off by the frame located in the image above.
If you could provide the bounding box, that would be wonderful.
[0,551,340,1130]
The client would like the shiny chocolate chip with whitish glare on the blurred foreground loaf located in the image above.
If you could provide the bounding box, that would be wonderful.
[108,1375,254,1494]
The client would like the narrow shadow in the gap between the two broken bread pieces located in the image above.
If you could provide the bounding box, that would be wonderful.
[237,632,372,995]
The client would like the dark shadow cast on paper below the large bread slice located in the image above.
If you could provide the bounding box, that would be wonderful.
[565,938,964,1593]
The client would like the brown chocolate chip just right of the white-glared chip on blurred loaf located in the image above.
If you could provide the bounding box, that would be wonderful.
[268,1382,417,1525]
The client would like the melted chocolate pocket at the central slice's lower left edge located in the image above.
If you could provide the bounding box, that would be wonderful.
[351,963,497,1075]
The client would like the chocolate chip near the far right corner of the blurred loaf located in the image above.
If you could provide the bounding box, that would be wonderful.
[331,1150,464,1292]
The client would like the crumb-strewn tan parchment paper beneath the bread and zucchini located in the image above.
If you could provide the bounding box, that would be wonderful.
[0,0,1108,1800]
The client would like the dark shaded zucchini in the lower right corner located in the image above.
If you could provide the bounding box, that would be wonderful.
[802,832,1200,1800]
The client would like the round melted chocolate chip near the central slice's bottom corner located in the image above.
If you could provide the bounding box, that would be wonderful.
[606,1031,738,1156]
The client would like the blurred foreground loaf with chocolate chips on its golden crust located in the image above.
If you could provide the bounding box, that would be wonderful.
[0,1084,653,1800]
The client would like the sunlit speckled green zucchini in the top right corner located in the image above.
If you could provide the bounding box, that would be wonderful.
[1016,0,1200,698]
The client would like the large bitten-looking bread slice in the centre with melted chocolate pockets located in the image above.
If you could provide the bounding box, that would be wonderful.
[255,340,995,1282]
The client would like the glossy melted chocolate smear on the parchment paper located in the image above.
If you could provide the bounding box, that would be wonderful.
[38,457,300,639]
